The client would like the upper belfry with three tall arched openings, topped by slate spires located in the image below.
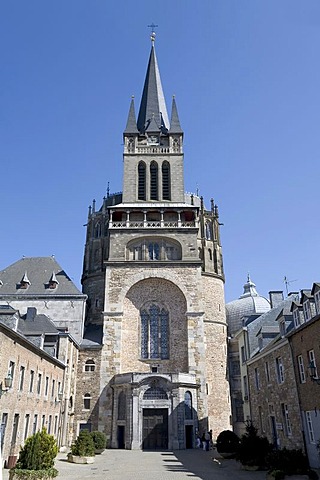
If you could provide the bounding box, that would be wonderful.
[123,33,185,204]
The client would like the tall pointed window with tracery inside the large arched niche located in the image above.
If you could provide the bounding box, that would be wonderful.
[140,305,169,359]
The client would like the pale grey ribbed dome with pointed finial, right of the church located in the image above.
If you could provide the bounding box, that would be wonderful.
[226,275,270,334]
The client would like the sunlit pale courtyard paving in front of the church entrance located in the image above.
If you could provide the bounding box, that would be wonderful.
[3,449,266,480]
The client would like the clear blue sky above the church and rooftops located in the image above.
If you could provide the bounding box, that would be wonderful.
[0,0,320,302]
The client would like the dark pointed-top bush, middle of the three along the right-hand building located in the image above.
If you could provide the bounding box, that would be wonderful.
[236,421,272,468]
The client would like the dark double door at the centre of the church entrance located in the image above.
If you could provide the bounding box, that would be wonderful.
[142,408,168,450]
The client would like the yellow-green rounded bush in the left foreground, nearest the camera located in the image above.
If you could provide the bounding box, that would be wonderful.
[15,428,58,477]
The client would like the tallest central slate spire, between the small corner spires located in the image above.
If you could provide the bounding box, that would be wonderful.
[137,41,170,133]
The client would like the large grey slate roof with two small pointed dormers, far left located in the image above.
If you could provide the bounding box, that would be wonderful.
[0,257,83,298]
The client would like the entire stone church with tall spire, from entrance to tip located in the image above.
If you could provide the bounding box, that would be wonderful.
[77,34,230,449]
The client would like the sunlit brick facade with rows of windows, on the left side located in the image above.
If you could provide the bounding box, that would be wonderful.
[0,323,65,466]
